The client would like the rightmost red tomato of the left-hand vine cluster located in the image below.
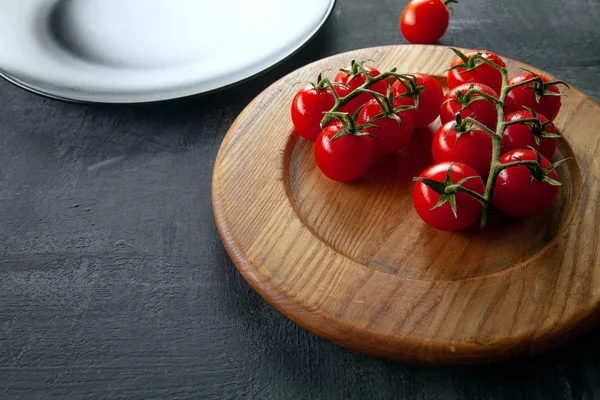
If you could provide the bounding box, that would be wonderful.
[392,74,444,128]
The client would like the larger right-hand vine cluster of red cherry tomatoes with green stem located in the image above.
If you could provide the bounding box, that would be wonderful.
[413,50,564,231]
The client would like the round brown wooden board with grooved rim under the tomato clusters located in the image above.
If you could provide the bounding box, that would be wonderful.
[212,45,600,364]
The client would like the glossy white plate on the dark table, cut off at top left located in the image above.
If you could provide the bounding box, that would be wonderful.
[0,0,335,103]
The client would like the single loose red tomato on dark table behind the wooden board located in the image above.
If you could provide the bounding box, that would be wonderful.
[400,0,450,44]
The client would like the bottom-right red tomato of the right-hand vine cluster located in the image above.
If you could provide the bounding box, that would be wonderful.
[492,149,559,217]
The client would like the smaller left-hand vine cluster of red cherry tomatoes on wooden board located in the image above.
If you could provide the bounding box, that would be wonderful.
[291,61,444,182]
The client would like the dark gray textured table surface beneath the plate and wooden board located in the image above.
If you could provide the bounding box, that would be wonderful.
[0,0,600,399]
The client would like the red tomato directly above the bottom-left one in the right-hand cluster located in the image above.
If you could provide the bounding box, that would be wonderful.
[431,121,492,176]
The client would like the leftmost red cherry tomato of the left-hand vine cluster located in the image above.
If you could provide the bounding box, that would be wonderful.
[292,85,335,142]
